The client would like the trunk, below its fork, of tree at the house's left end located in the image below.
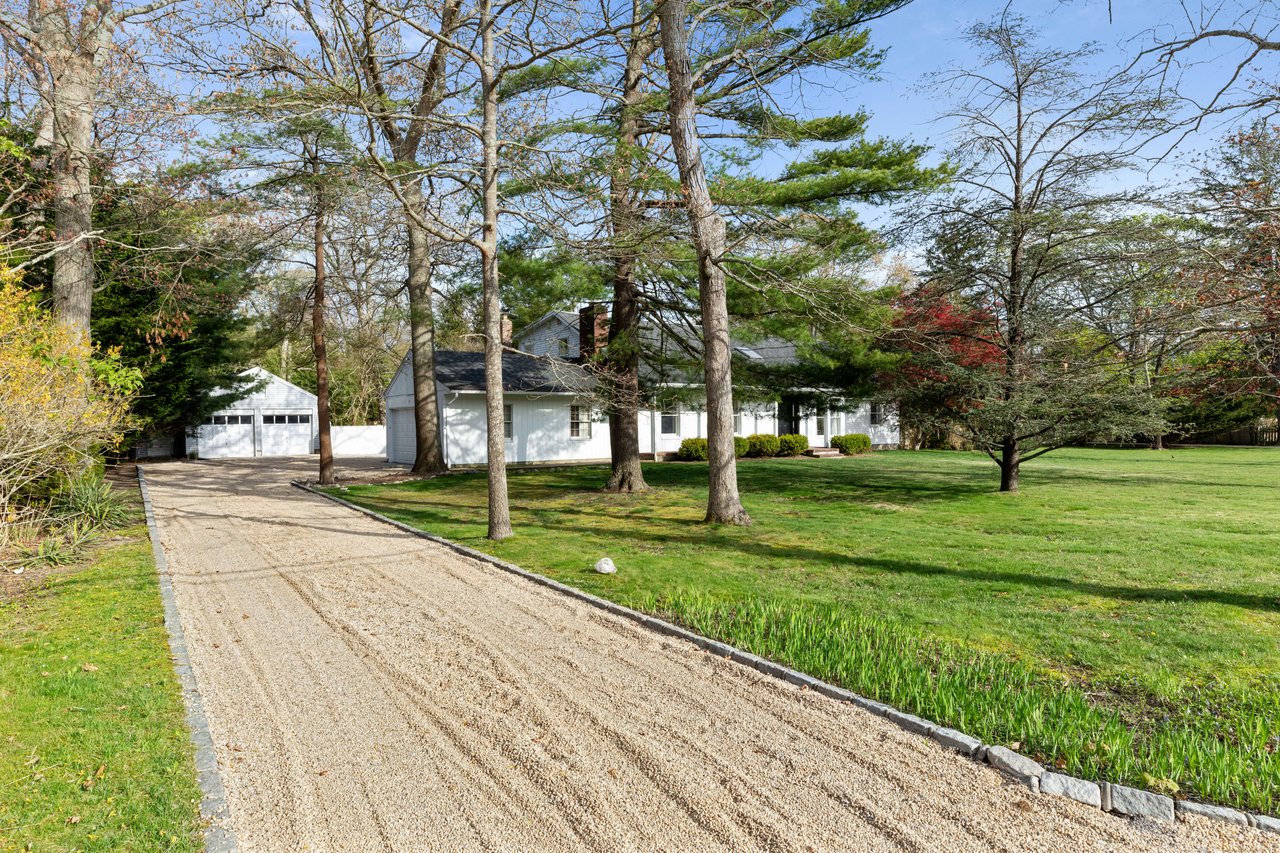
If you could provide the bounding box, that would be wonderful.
[404,182,445,476]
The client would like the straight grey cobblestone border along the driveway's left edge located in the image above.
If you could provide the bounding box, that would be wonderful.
[137,465,237,853]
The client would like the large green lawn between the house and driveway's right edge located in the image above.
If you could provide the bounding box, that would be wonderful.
[344,448,1280,813]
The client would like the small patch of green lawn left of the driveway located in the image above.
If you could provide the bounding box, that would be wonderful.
[0,514,201,850]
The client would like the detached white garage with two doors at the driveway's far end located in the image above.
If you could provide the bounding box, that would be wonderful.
[188,368,320,459]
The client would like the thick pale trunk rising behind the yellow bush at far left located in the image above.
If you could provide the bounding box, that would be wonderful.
[50,51,99,342]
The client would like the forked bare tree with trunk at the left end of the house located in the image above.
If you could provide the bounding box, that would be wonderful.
[202,0,461,475]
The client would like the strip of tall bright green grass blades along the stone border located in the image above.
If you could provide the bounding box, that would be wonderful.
[626,590,1280,811]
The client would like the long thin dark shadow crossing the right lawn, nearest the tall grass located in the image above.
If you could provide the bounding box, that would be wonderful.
[517,512,1280,612]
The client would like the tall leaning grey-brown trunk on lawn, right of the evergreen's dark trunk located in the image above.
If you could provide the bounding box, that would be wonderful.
[658,0,751,524]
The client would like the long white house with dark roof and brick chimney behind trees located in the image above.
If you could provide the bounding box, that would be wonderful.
[387,305,900,466]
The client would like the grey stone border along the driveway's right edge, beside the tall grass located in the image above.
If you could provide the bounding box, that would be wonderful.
[293,480,1280,834]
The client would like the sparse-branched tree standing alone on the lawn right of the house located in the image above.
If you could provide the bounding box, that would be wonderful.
[918,15,1166,492]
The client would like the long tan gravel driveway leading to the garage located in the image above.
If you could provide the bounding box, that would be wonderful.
[147,460,1280,853]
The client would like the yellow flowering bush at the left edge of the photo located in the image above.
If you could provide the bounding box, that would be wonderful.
[0,268,141,548]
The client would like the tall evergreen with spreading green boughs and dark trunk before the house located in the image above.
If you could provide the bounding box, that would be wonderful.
[514,0,945,491]
